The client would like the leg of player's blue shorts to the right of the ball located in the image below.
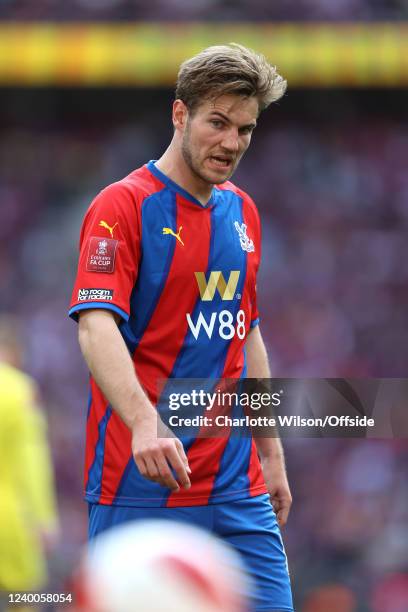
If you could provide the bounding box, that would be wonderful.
[214,495,293,612]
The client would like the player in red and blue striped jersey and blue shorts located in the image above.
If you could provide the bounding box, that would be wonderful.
[70,44,293,612]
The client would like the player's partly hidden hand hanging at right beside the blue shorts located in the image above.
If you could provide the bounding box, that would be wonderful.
[262,457,292,527]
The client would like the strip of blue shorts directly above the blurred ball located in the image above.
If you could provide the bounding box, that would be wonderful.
[88,504,212,540]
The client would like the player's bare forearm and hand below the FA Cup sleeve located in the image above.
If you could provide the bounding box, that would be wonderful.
[79,309,190,491]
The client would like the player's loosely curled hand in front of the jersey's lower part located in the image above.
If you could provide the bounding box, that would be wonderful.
[132,408,191,491]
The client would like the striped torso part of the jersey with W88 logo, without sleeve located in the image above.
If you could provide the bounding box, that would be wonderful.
[81,164,265,506]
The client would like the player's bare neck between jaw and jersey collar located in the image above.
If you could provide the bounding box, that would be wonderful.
[156,144,213,206]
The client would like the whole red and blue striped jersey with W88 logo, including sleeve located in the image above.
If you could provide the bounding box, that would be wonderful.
[70,161,266,507]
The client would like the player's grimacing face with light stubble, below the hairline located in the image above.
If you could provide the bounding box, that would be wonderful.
[182,94,259,184]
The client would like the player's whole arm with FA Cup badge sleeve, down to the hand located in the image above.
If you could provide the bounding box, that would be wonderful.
[70,181,190,490]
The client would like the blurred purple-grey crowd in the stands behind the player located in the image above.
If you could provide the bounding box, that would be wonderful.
[0,0,408,612]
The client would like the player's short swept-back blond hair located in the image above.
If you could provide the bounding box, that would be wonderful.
[176,43,287,112]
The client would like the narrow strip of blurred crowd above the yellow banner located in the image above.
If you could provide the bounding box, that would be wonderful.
[0,0,408,21]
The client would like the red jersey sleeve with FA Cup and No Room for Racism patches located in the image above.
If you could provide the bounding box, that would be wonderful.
[69,183,141,321]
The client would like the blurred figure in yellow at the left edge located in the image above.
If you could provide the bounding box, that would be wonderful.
[0,316,57,609]
